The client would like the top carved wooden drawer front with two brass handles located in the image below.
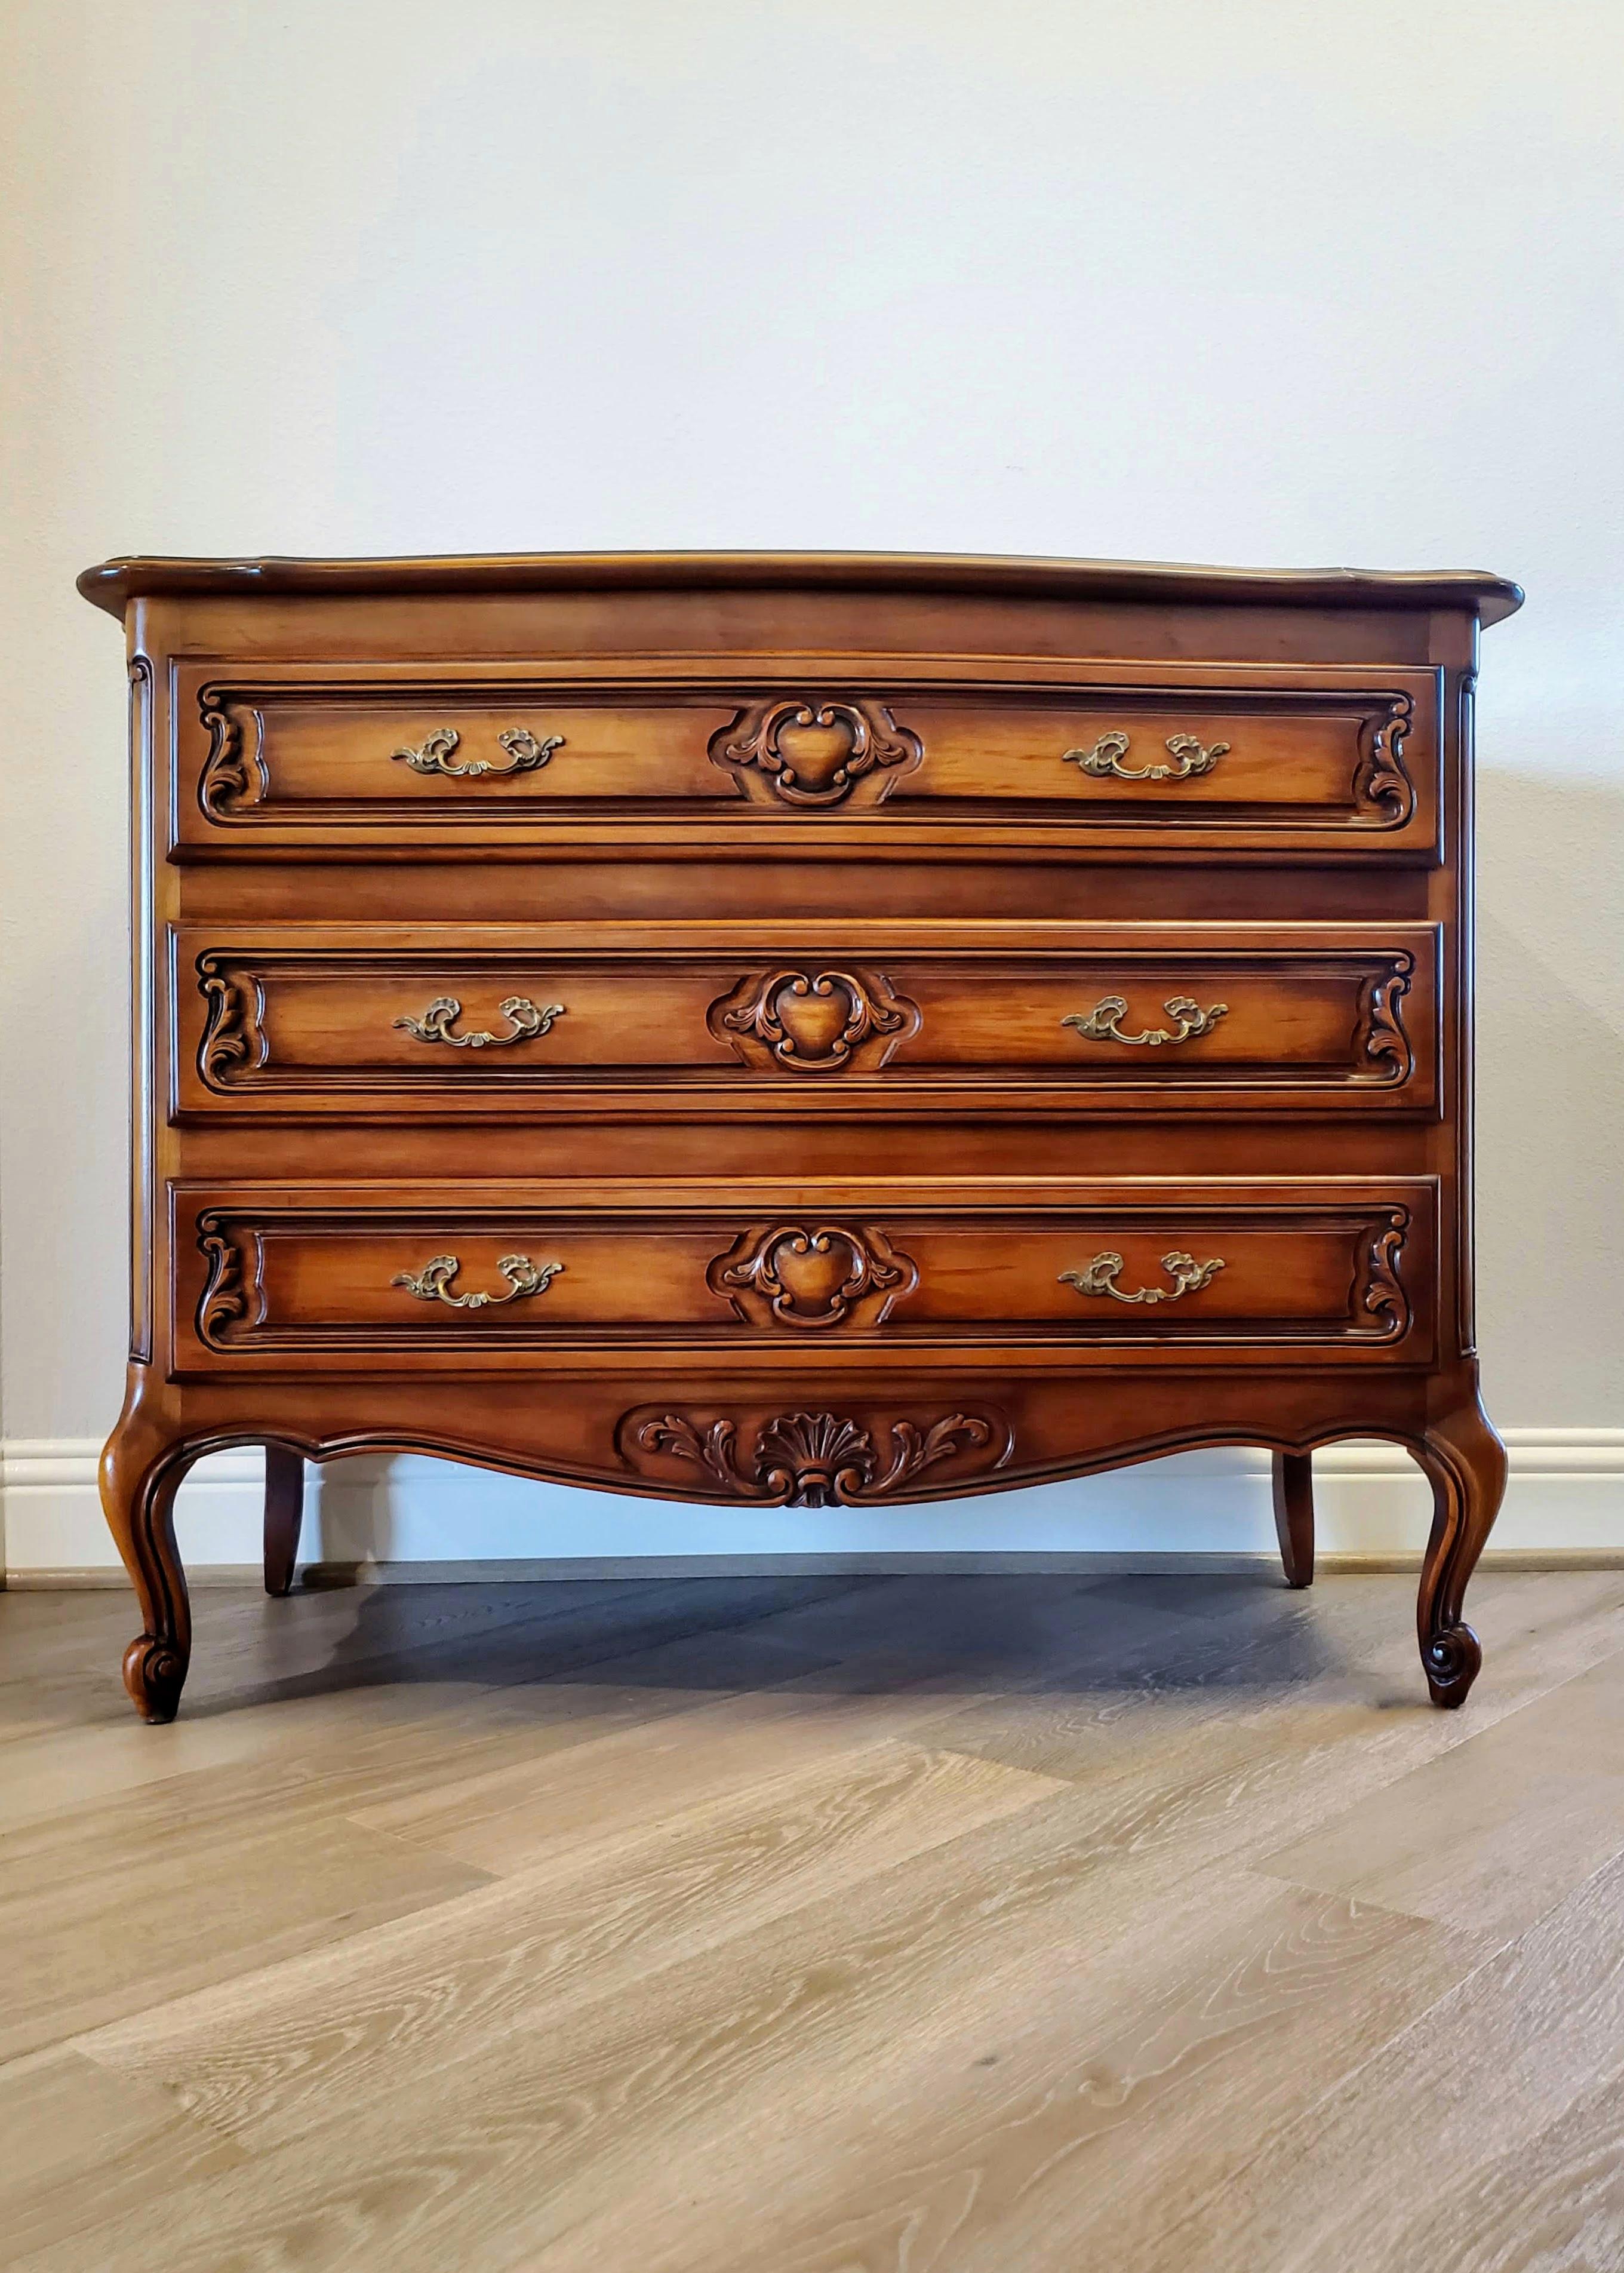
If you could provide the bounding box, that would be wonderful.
[173,657,1440,859]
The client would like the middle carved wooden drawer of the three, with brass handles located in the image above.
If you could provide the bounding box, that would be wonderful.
[173,923,1438,1116]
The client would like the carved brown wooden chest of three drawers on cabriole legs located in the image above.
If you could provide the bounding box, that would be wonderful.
[79,555,1520,1721]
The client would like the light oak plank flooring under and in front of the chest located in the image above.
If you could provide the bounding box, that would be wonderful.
[0,1571,1624,2273]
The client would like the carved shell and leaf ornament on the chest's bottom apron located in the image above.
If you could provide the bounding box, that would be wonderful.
[618,1409,1011,1507]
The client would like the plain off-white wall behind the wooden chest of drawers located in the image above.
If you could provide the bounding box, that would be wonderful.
[0,0,1624,1559]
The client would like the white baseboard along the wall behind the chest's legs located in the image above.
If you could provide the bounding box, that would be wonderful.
[0,1427,1624,1587]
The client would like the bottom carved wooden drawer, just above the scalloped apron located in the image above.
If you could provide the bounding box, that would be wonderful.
[175,1179,1435,1371]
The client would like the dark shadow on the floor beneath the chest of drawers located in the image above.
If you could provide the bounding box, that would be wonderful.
[174,1573,1420,1718]
